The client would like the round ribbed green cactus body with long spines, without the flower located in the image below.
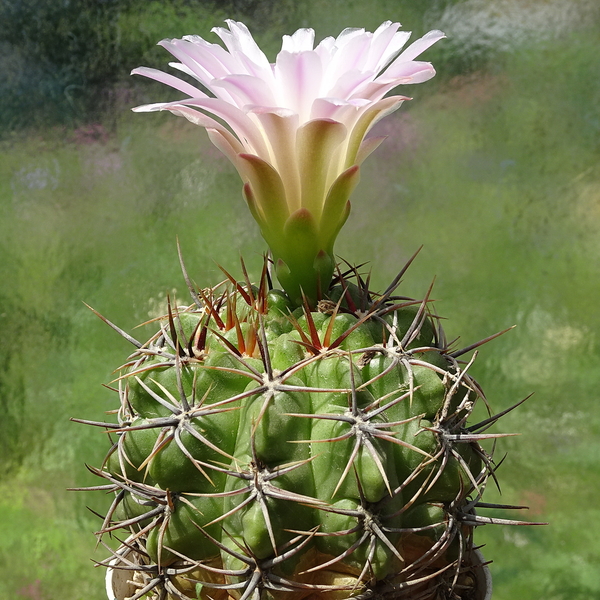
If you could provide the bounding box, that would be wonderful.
[75,257,529,600]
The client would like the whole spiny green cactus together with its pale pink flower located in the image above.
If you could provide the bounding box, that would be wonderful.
[77,16,536,600]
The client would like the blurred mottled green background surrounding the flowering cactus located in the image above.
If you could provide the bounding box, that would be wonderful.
[0,0,600,600]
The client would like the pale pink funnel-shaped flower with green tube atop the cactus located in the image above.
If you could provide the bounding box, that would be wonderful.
[132,20,444,305]
